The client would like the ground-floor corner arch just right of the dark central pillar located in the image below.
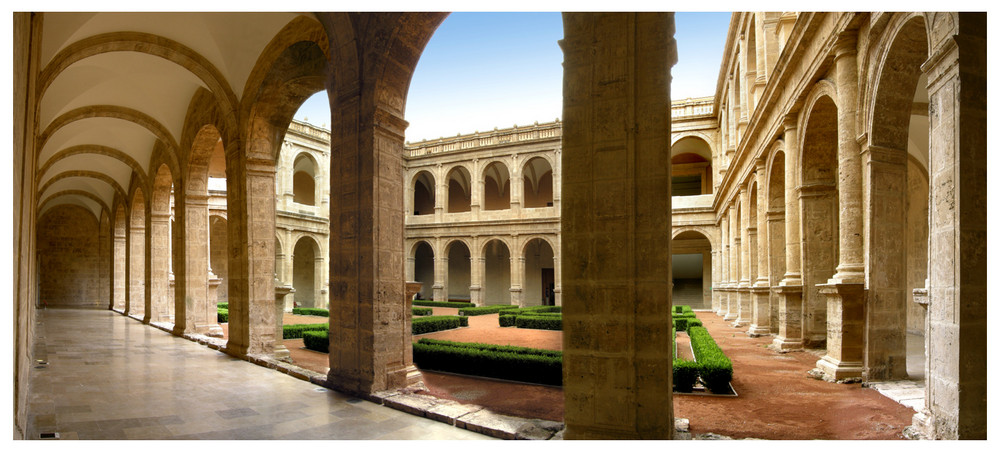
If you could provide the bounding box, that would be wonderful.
[670,226,714,309]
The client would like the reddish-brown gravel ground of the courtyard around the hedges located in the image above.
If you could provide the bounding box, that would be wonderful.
[229,308,914,440]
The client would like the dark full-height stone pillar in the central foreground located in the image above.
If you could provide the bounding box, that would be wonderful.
[560,13,676,439]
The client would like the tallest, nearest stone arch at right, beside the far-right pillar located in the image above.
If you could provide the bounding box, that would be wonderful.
[864,14,930,381]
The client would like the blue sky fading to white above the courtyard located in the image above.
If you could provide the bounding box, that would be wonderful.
[295,12,731,141]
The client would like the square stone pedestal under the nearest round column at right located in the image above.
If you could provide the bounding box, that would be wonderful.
[816,283,865,381]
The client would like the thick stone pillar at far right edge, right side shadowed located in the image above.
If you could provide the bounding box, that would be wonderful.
[914,13,987,439]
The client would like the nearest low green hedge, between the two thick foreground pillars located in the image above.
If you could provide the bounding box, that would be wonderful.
[413,339,562,385]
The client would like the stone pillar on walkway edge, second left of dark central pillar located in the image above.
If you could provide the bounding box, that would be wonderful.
[226,157,276,357]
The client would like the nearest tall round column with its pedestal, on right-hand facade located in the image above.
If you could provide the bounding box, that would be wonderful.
[816,30,868,380]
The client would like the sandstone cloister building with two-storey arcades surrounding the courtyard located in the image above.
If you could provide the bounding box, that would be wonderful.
[12,12,987,439]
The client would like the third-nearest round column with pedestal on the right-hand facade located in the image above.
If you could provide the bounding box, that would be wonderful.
[748,158,771,336]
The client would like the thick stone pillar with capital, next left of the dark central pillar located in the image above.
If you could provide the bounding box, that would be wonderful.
[327,103,414,394]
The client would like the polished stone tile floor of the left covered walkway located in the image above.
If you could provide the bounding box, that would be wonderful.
[27,308,490,440]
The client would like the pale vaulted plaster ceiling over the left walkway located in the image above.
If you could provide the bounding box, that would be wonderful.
[37,13,303,219]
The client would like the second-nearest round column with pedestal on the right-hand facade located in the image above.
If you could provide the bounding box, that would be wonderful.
[771,113,803,351]
